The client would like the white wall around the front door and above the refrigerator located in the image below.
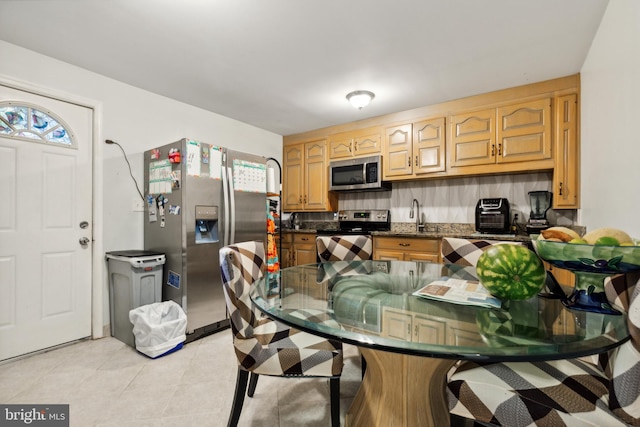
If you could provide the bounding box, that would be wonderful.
[0,40,282,331]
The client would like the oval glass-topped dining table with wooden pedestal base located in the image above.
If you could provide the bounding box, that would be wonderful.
[251,260,629,427]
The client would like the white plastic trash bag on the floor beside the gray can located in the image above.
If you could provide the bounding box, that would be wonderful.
[129,301,187,359]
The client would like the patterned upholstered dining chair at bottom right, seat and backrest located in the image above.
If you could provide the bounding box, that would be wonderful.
[447,274,640,427]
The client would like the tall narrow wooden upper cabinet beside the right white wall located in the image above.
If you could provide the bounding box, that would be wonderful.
[552,94,580,209]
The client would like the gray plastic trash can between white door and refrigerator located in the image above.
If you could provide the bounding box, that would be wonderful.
[106,250,165,347]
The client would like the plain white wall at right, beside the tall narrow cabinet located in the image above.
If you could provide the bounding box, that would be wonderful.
[580,0,640,238]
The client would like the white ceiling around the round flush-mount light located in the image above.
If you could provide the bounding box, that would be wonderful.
[0,0,608,135]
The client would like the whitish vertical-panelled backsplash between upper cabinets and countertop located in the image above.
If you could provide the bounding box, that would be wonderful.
[339,172,577,225]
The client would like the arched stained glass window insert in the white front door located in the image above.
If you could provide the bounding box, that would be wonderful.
[0,102,76,147]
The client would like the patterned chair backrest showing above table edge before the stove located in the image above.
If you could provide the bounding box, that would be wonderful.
[316,235,373,261]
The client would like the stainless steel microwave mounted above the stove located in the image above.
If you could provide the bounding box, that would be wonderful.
[329,156,391,191]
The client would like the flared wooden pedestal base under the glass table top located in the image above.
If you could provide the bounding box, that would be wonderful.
[345,347,456,427]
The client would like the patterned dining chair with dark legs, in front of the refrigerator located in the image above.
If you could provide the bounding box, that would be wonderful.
[220,242,343,427]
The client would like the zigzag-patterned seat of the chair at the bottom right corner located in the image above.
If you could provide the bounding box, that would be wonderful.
[447,359,625,427]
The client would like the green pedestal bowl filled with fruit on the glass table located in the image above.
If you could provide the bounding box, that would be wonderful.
[531,227,640,313]
